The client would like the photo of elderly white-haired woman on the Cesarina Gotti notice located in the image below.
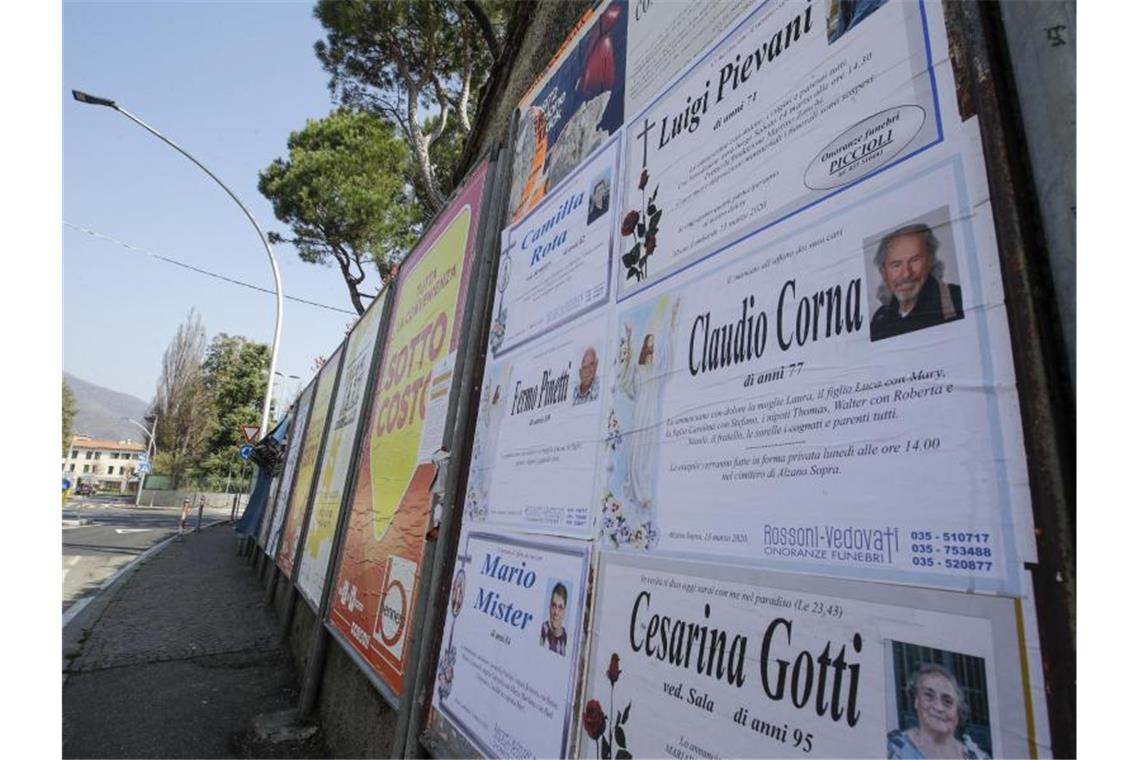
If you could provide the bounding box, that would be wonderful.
[887,641,993,760]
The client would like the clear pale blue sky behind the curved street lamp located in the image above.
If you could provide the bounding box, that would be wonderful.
[59,2,375,410]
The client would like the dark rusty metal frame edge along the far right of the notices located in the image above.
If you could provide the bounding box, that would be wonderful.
[944,0,1076,757]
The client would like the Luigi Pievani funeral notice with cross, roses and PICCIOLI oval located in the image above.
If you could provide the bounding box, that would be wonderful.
[614,0,950,299]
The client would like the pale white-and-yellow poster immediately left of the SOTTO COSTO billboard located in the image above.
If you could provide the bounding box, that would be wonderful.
[296,293,386,606]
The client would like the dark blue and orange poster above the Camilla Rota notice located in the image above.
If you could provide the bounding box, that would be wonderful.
[508,0,629,221]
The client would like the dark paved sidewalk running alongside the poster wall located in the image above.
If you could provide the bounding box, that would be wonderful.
[63,524,329,758]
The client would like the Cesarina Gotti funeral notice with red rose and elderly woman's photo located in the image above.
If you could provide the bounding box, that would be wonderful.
[578,554,1049,758]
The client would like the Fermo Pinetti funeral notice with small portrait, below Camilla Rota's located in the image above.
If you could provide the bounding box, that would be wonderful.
[464,312,612,538]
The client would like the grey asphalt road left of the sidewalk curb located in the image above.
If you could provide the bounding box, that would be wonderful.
[63,499,181,612]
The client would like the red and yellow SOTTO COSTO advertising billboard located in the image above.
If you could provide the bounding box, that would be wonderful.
[329,164,487,694]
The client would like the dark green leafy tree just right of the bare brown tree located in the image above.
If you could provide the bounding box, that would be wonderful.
[194,333,269,479]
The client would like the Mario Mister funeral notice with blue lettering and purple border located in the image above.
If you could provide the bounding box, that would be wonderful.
[433,532,589,758]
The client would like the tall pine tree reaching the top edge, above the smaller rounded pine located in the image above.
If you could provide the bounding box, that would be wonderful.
[314,0,508,218]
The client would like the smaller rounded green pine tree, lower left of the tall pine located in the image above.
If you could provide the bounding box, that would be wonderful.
[258,108,423,313]
